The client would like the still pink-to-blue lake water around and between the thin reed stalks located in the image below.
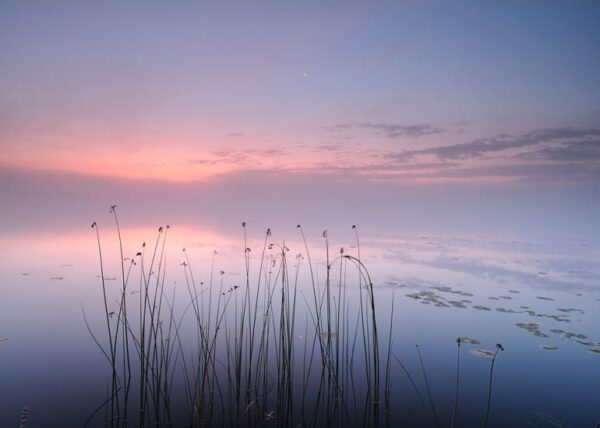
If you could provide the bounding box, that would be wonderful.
[0,227,600,427]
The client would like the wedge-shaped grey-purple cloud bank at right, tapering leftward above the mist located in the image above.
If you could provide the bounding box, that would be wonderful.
[310,127,600,184]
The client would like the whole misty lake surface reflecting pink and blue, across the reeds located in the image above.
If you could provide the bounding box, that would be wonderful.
[0,216,600,427]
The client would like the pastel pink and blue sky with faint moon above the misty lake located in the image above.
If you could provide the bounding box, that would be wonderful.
[0,2,600,234]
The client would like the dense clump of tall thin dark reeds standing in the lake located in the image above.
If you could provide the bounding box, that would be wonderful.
[82,211,506,428]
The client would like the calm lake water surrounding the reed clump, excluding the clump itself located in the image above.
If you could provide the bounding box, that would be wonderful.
[0,221,600,427]
